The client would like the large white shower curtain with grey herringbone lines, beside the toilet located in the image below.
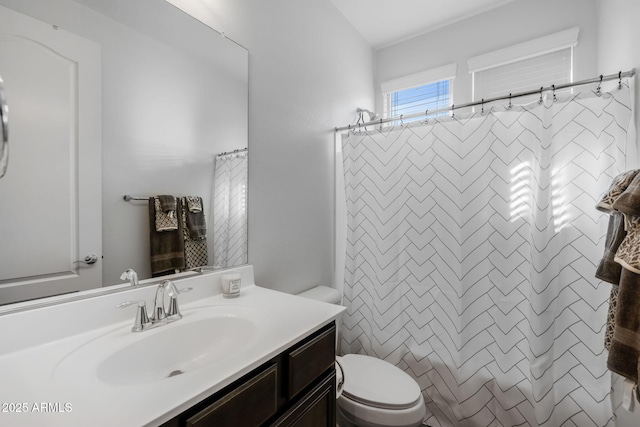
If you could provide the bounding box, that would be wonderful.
[341,85,635,427]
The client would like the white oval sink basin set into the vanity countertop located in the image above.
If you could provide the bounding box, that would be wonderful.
[54,306,268,385]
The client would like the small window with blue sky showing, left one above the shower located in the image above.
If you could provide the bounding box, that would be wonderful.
[381,64,457,124]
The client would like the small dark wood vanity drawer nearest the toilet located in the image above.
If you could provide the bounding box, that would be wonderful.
[287,325,336,399]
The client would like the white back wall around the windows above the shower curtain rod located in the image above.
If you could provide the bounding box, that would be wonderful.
[376,0,600,111]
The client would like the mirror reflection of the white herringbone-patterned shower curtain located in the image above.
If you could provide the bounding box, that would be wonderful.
[212,152,248,267]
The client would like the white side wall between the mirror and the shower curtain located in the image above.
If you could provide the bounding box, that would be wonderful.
[209,0,374,293]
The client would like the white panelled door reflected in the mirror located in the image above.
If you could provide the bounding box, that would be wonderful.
[0,6,102,304]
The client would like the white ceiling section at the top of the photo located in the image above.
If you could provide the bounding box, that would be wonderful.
[331,0,514,49]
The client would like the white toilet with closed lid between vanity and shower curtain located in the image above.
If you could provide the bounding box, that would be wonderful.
[298,286,427,427]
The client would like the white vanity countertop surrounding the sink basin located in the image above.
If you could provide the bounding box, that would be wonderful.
[0,272,344,427]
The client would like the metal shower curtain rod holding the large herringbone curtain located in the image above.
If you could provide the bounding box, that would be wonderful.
[334,68,636,132]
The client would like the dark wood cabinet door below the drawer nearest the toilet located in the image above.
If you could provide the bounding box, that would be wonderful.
[271,372,336,427]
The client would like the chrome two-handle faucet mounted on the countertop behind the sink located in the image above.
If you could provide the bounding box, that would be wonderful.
[116,280,192,332]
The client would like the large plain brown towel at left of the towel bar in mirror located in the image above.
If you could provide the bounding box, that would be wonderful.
[149,197,185,277]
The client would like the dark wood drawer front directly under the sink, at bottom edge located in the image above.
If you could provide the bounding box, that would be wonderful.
[186,364,278,427]
